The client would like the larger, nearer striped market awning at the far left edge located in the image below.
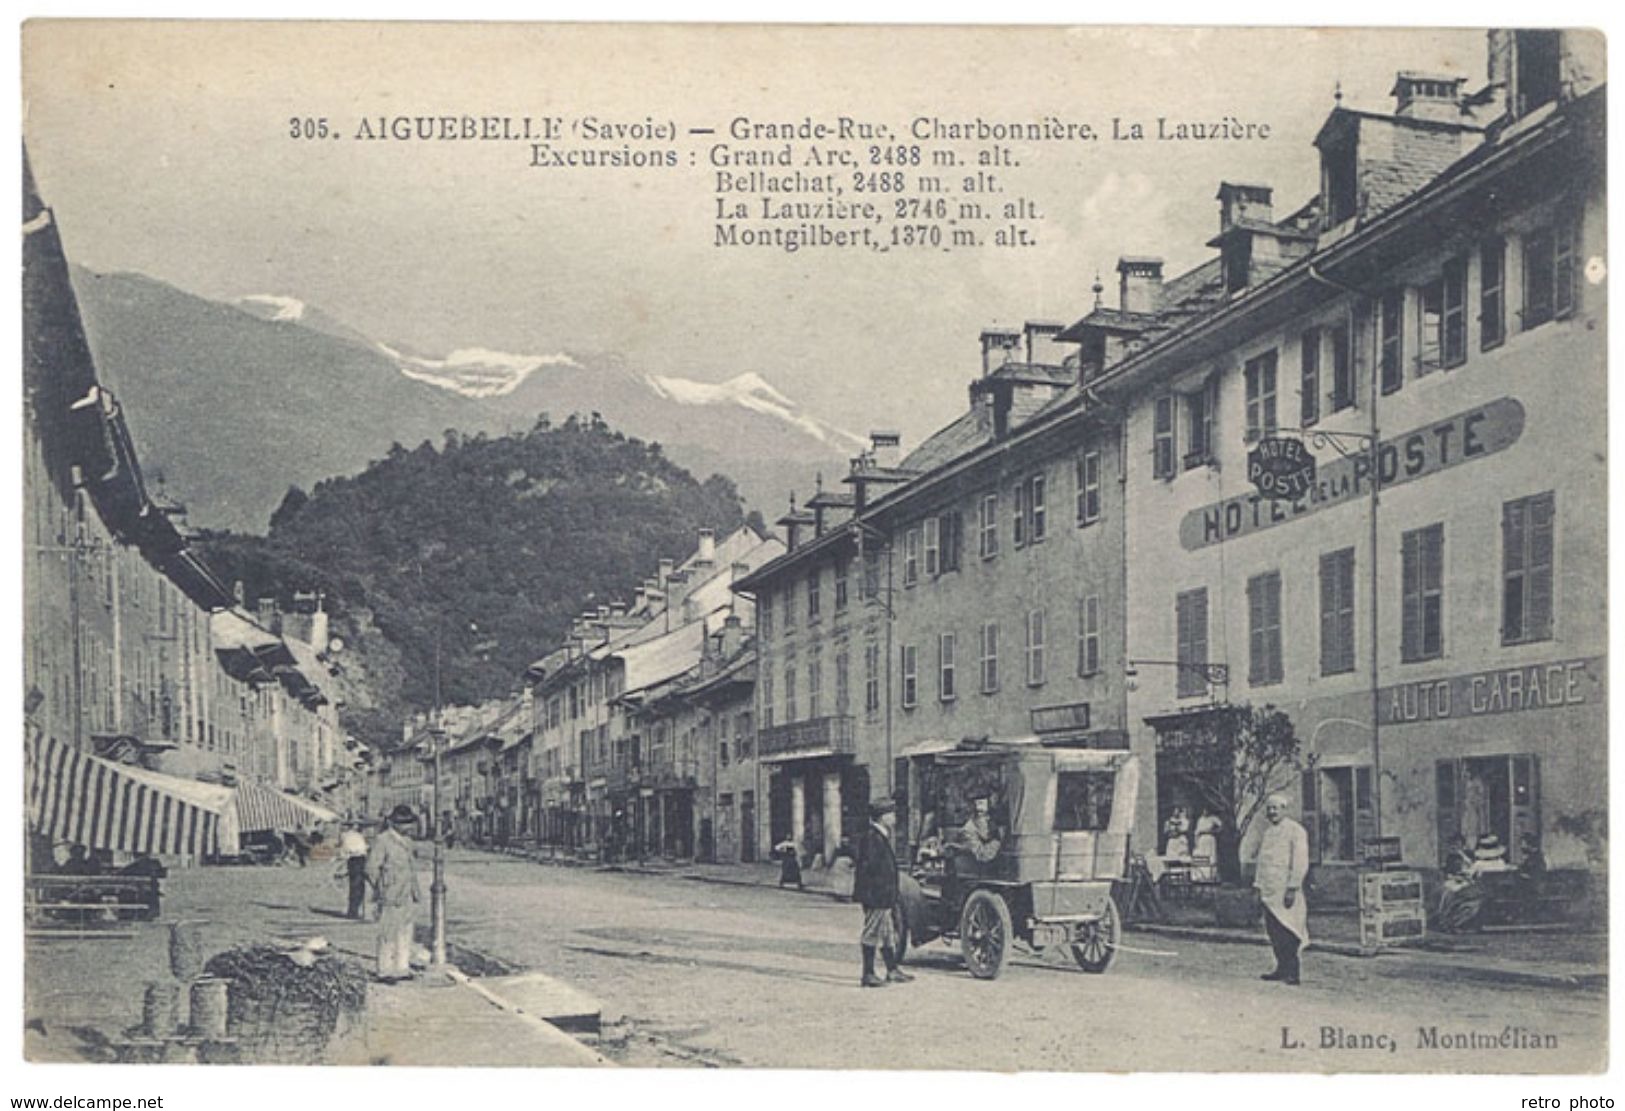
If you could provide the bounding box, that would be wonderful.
[26,737,239,856]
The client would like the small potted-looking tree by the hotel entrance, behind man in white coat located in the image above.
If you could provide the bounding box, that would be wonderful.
[1170,703,1303,882]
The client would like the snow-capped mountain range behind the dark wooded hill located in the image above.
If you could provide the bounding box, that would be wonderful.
[73,268,863,531]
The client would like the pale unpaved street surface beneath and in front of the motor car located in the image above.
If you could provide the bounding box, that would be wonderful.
[429,851,1606,1072]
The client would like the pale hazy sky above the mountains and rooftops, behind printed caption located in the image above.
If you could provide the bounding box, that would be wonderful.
[23,21,1484,447]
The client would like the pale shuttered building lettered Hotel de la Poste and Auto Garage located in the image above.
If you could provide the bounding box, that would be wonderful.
[1097,31,1607,897]
